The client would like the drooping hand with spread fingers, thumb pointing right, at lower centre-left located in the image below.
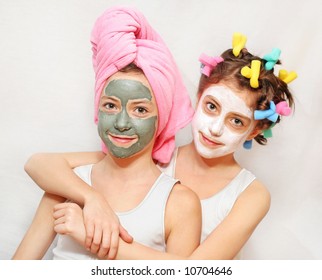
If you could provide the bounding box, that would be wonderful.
[83,193,133,259]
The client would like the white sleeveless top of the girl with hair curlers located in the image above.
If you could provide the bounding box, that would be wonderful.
[160,148,256,242]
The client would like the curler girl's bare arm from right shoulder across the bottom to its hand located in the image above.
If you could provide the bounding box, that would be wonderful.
[49,178,269,260]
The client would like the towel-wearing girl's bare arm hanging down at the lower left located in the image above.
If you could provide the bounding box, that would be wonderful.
[12,193,63,260]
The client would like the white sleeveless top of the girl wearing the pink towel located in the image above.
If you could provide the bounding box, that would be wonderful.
[53,165,178,260]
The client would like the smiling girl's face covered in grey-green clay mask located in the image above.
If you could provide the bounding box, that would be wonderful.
[98,79,157,158]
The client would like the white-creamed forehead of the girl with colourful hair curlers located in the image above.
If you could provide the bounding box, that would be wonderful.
[202,84,253,118]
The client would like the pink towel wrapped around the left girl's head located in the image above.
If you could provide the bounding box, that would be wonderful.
[91,7,194,163]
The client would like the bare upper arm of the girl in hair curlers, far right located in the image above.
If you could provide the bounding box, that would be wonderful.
[190,181,270,260]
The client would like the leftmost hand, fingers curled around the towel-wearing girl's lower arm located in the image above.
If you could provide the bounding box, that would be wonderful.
[53,203,86,246]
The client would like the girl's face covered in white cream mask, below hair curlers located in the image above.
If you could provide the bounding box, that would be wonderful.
[192,85,255,158]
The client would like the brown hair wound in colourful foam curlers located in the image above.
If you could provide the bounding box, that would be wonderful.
[198,48,294,145]
